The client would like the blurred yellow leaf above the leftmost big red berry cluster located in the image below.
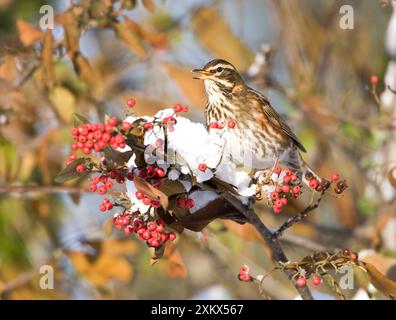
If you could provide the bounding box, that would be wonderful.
[49,86,76,123]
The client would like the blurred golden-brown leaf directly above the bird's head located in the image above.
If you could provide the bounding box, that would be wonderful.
[192,6,254,71]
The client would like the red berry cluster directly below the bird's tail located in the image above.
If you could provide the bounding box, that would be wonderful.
[270,167,301,213]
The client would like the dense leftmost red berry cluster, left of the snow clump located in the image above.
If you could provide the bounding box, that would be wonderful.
[71,118,132,154]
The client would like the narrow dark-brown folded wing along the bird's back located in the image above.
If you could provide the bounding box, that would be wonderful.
[250,89,307,152]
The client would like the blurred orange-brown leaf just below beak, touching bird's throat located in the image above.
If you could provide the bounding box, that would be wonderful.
[163,63,206,110]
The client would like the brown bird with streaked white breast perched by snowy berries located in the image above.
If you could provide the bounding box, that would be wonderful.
[193,59,305,169]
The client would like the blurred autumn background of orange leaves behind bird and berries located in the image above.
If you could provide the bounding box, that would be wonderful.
[0,0,396,299]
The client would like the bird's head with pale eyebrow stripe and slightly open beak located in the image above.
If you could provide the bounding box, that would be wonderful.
[192,59,244,91]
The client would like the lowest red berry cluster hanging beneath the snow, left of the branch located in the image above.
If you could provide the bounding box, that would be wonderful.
[114,213,176,248]
